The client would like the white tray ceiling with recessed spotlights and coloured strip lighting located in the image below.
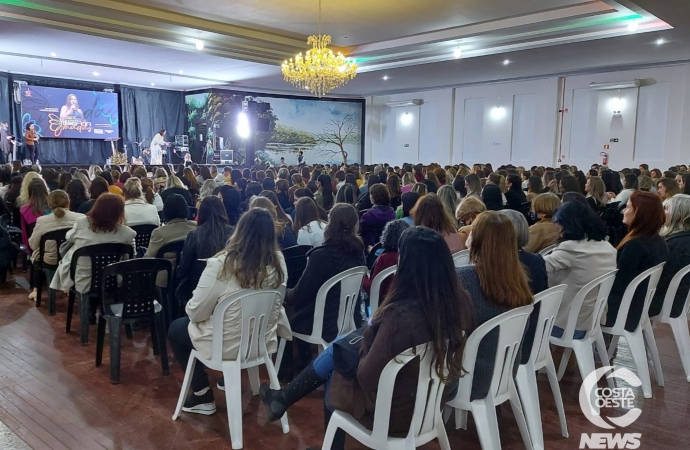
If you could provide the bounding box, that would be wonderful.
[0,0,690,96]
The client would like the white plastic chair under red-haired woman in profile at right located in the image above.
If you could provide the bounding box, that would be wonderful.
[601,262,666,398]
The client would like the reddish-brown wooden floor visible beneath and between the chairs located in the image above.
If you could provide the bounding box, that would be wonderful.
[0,274,690,450]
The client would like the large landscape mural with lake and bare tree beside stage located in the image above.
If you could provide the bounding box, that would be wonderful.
[185,90,363,165]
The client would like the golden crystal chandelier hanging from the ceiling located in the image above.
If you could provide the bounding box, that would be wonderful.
[282,0,357,97]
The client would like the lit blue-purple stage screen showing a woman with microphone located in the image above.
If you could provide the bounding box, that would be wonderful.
[21,86,120,139]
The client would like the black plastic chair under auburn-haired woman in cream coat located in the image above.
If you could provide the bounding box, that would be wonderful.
[65,244,134,345]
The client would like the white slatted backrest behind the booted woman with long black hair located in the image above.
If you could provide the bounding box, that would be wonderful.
[372,344,445,442]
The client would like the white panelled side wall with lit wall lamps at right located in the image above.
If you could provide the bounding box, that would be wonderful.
[365,64,690,169]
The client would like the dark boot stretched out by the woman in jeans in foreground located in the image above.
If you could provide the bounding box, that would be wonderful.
[259,364,327,422]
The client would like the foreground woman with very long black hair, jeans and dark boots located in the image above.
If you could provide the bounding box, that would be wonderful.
[261,229,472,449]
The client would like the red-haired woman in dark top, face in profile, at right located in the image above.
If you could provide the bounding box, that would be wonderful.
[606,191,669,331]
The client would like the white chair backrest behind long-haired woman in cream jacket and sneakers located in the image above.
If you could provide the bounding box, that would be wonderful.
[211,289,285,365]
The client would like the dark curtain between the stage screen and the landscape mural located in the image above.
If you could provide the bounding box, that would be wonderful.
[120,86,185,157]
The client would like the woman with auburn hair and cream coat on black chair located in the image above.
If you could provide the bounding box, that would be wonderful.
[50,193,137,294]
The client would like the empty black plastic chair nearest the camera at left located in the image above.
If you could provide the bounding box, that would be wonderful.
[96,258,172,384]
